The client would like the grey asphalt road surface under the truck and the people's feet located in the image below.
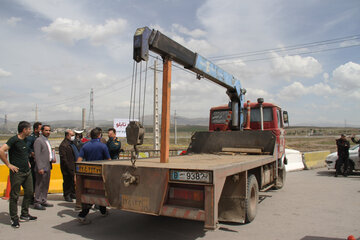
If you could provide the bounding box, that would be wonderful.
[0,169,360,240]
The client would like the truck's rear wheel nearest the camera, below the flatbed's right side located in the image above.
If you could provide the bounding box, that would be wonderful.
[245,174,259,223]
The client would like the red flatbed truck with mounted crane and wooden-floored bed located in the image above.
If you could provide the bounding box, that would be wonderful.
[75,27,287,230]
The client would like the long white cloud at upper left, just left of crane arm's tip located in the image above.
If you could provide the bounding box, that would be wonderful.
[41,18,127,45]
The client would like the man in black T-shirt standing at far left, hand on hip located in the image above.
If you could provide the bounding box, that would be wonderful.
[0,121,37,228]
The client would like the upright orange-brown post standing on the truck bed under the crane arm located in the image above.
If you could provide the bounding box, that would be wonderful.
[160,58,171,163]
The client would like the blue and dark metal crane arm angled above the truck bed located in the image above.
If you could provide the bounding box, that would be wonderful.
[133,27,246,129]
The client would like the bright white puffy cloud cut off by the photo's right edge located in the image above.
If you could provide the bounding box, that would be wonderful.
[331,62,360,90]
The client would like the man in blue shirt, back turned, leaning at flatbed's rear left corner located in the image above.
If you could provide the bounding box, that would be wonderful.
[76,128,111,224]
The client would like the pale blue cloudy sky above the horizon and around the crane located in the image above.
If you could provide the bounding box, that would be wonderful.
[0,0,360,126]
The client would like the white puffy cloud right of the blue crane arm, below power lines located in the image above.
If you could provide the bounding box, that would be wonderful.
[272,53,322,81]
